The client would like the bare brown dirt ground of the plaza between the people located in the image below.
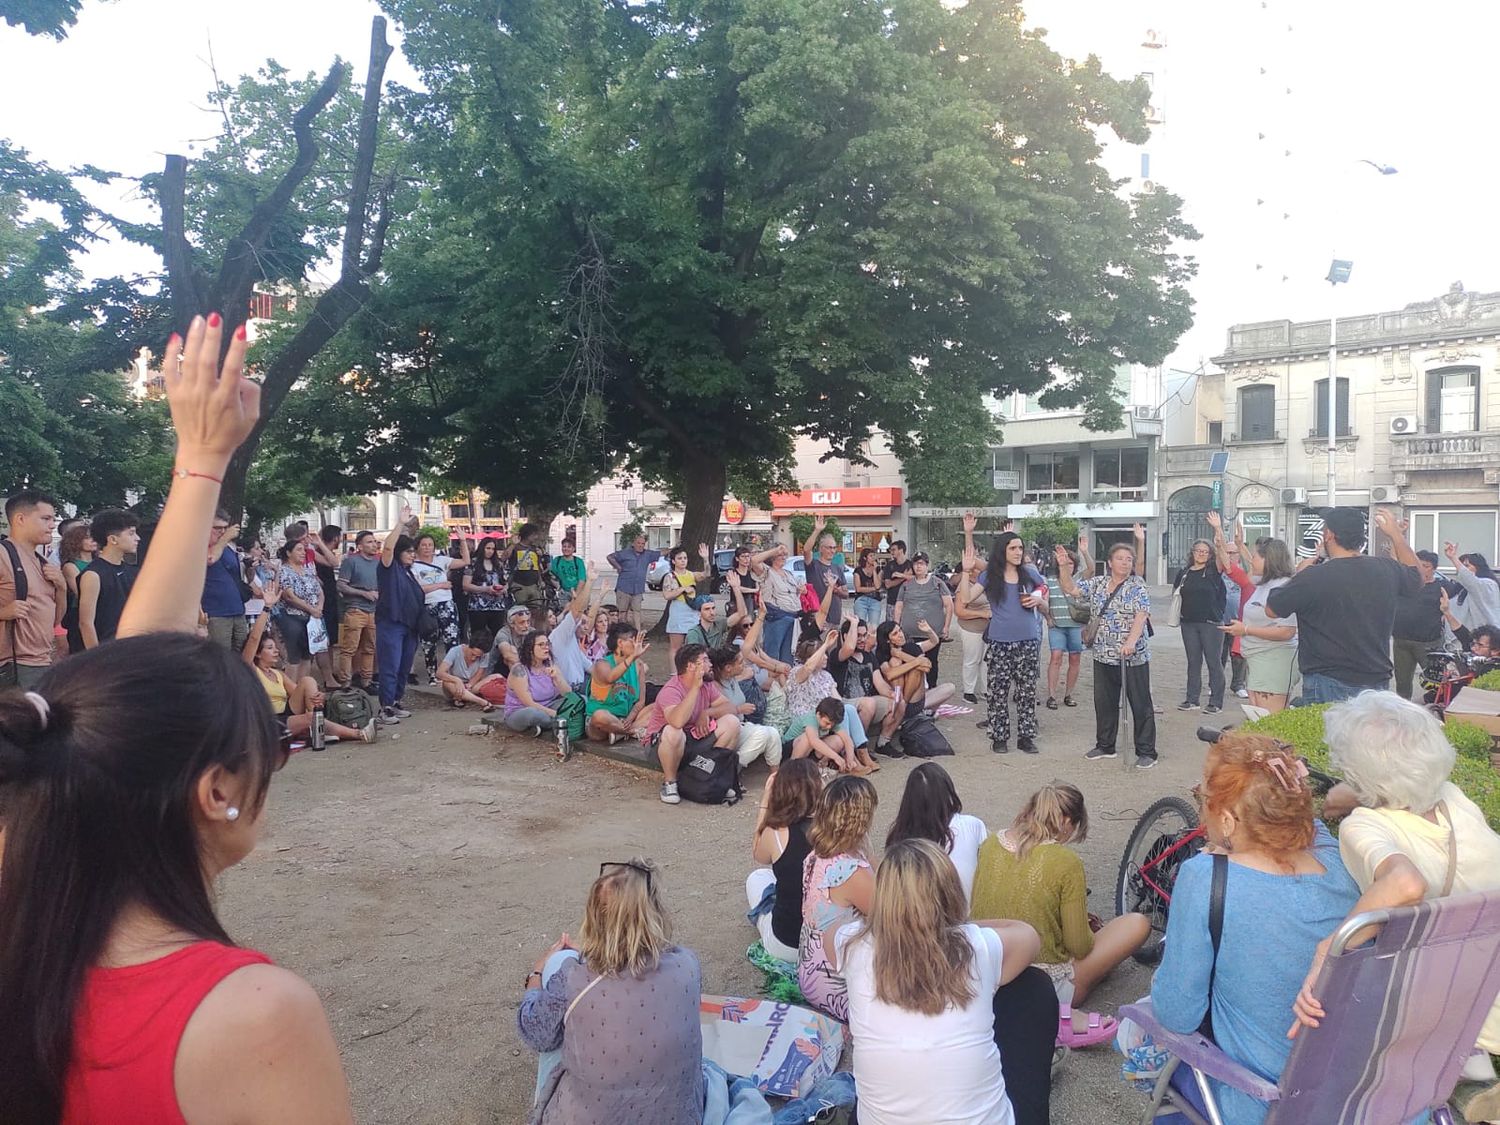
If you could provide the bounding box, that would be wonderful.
[221,612,1212,1125]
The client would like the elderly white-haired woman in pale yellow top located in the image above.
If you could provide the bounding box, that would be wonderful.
[1293,692,1500,1082]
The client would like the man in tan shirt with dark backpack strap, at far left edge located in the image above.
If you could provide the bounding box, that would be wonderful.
[0,491,68,690]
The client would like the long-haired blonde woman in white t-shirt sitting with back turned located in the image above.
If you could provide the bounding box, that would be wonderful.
[825,839,1052,1125]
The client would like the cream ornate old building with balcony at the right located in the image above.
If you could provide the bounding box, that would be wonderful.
[1161,284,1500,582]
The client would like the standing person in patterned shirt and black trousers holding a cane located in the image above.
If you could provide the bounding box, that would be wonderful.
[1055,543,1157,770]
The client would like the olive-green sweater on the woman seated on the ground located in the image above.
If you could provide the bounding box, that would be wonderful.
[971,833,1094,965]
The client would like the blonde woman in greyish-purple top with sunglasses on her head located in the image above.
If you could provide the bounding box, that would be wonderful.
[516,858,705,1125]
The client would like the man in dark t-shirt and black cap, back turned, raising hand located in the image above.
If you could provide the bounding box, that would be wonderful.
[1266,509,1422,704]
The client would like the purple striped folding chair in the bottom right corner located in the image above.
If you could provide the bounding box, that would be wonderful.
[1121,893,1500,1125]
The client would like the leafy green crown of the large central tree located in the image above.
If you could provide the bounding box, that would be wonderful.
[387,0,1193,555]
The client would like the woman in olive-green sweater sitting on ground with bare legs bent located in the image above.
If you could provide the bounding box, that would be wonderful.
[974,782,1151,1047]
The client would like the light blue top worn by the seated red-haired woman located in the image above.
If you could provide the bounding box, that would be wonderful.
[1151,821,1359,1125]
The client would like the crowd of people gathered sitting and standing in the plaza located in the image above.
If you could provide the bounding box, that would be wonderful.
[0,315,1500,1125]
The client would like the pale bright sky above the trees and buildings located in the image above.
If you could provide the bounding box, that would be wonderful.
[0,0,1500,379]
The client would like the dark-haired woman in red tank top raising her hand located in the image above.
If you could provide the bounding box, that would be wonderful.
[0,315,353,1125]
